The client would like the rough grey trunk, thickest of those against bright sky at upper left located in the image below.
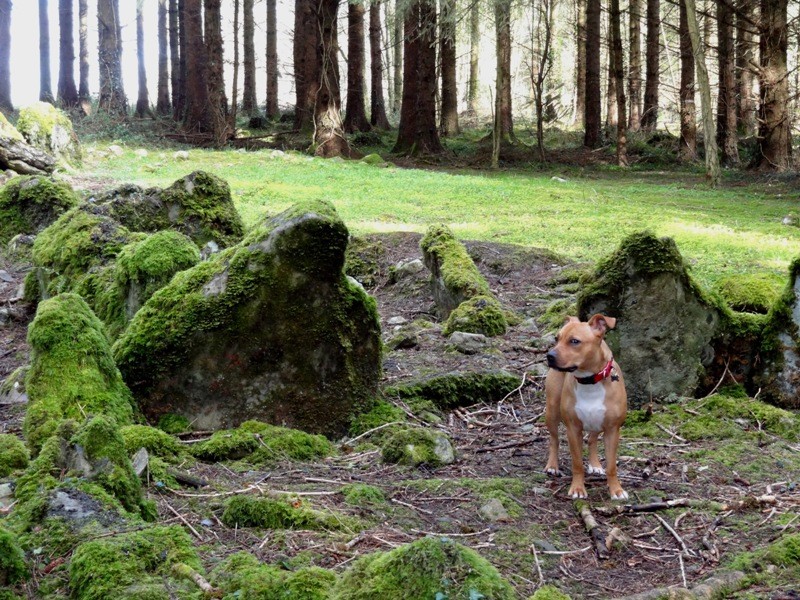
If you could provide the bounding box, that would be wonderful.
[97,0,128,117]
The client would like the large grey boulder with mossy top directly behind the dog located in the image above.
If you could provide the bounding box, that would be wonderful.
[578,232,724,406]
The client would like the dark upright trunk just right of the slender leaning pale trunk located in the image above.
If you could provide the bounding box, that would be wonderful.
[717,0,739,167]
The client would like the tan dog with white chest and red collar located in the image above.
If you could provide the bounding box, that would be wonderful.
[545,314,628,500]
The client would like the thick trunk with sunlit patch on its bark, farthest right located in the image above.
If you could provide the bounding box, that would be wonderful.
[755,0,791,171]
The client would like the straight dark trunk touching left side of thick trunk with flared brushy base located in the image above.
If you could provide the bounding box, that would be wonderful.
[294,0,320,132]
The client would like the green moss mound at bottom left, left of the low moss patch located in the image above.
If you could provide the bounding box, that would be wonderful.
[69,526,202,600]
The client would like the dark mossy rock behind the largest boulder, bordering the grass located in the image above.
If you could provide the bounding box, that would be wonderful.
[95,171,244,248]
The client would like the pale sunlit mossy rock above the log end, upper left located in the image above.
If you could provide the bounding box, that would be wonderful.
[17,102,82,167]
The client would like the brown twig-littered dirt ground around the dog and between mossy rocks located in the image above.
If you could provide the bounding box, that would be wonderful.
[0,233,800,600]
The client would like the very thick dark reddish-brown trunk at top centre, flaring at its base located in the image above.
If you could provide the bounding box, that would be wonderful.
[392,0,444,156]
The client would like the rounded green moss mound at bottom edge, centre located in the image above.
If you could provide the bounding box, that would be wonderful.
[331,537,517,600]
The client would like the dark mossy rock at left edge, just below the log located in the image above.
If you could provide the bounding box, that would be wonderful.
[0,175,78,244]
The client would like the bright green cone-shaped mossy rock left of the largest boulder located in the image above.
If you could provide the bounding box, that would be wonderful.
[24,294,133,451]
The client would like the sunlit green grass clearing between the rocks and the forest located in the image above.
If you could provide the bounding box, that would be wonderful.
[79,144,800,285]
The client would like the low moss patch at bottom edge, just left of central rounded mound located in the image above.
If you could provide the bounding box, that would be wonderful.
[211,552,336,600]
